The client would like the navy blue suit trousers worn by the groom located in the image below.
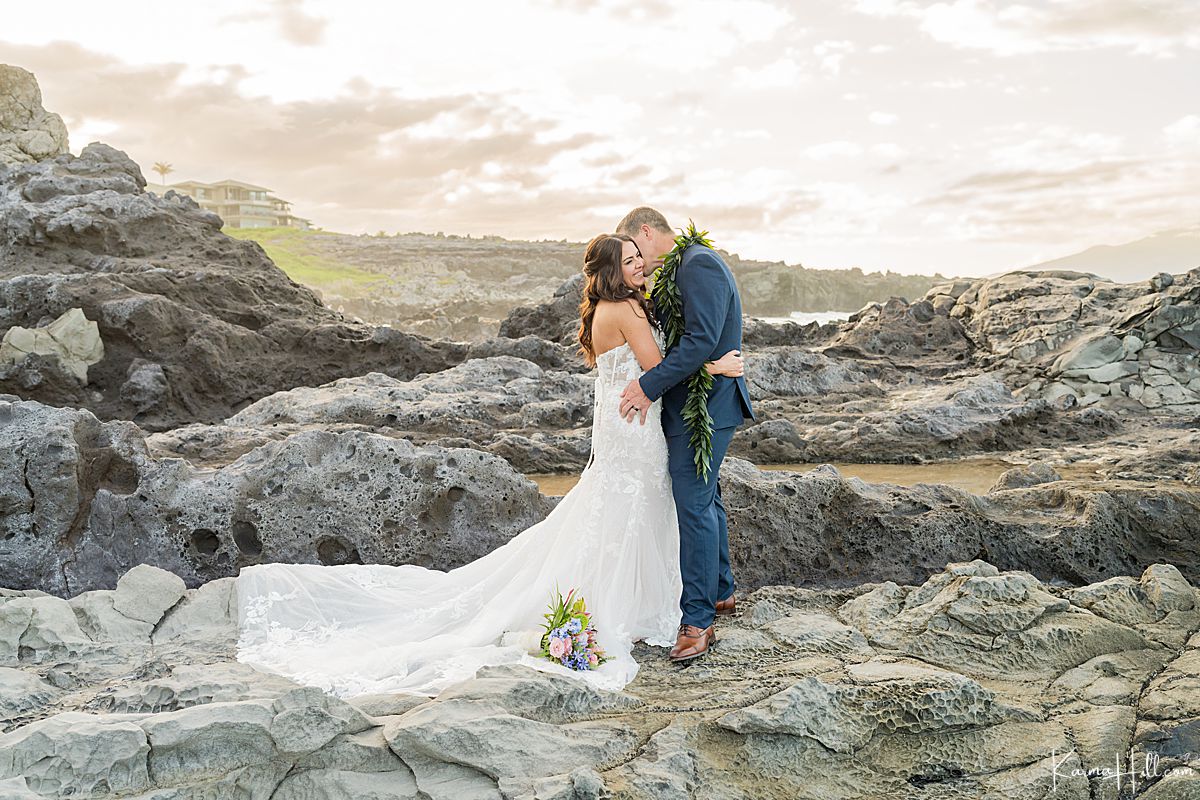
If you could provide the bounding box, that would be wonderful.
[667,426,737,627]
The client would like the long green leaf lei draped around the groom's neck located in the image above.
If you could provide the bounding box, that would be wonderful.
[650,219,713,483]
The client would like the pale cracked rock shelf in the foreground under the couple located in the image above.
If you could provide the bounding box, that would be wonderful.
[0,560,1200,800]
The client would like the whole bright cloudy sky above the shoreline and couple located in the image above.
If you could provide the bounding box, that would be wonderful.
[0,0,1200,275]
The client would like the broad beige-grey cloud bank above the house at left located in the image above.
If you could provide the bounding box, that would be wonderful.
[0,42,657,237]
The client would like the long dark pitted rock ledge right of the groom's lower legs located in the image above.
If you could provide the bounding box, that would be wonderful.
[721,458,1200,587]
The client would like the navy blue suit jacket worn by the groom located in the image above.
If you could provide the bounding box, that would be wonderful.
[638,245,754,437]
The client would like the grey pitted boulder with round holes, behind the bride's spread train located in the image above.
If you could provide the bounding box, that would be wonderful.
[0,401,548,594]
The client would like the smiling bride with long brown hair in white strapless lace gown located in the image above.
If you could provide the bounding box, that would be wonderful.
[236,234,743,697]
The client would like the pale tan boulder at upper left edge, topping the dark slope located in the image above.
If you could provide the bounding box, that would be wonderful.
[0,64,67,165]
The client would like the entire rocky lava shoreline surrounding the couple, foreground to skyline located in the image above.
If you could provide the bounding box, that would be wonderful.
[0,65,1200,800]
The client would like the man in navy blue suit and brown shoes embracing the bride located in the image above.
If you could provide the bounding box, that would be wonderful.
[617,206,754,661]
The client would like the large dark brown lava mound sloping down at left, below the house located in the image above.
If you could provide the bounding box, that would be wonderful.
[0,143,564,429]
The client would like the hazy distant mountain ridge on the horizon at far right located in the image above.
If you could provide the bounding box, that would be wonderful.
[1026,225,1200,283]
